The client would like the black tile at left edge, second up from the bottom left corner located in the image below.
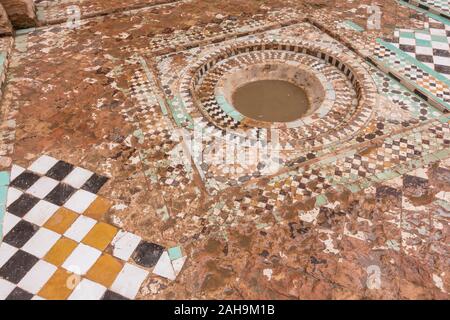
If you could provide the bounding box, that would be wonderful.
[0,250,39,284]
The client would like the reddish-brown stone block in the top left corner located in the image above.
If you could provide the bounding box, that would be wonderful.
[0,0,36,29]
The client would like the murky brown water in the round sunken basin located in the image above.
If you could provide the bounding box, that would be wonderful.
[233,80,310,122]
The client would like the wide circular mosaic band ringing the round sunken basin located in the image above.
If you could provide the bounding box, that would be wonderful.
[180,40,376,148]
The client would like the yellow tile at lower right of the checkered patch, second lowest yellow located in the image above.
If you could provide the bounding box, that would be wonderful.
[86,254,123,288]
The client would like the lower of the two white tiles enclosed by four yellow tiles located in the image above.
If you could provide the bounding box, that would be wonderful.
[62,243,101,275]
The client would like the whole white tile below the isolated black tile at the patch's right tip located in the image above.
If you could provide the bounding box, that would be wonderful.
[111,263,148,299]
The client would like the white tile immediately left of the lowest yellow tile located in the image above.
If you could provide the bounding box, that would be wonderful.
[18,260,58,294]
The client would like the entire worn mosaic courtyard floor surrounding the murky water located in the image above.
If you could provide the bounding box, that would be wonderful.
[0,0,450,299]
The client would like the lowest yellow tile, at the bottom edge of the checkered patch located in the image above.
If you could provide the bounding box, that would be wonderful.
[38,269,81,300]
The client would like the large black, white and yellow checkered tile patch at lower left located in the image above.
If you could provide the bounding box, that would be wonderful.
[0,156,184,300]
